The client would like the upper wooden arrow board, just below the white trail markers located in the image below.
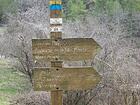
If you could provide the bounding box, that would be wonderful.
[32,38,101,62]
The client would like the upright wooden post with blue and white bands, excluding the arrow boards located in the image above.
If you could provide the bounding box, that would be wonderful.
[50,0,63,105]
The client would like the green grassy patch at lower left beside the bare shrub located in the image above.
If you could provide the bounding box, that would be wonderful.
[0,59,31,105]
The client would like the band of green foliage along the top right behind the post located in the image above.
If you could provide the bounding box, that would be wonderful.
[64,0,140,19]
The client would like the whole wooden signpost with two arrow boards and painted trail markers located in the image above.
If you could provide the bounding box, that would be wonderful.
[32,0,101,105]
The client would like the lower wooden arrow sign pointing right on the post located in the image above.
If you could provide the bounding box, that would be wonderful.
[33,67,101,91]
